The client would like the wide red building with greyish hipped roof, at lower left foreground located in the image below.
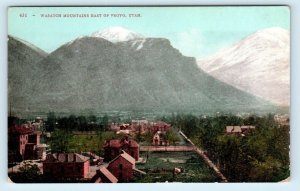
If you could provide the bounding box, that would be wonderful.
[43,153,90,179]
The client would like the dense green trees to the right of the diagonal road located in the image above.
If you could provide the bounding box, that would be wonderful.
[158,114,290,182]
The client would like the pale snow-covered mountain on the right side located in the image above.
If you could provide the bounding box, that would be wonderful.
[198,27,290,106]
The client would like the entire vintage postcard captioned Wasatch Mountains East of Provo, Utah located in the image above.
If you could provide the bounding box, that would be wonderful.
[7,6,290,183]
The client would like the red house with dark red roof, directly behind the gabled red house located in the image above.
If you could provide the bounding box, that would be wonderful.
[103,136,139,162]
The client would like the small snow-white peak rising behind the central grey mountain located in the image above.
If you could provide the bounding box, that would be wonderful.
[91,27,144,43]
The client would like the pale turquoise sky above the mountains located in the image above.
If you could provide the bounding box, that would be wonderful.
[8,6,290,58]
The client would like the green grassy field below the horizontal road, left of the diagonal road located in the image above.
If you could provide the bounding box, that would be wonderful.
[136,152,218,183]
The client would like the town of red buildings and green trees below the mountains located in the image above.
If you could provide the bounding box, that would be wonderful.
[8,113,289,183]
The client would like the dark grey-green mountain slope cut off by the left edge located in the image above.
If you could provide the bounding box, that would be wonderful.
[8,36,47,113]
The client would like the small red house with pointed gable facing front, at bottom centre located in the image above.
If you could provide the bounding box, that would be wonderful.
[107,151,135,182]
